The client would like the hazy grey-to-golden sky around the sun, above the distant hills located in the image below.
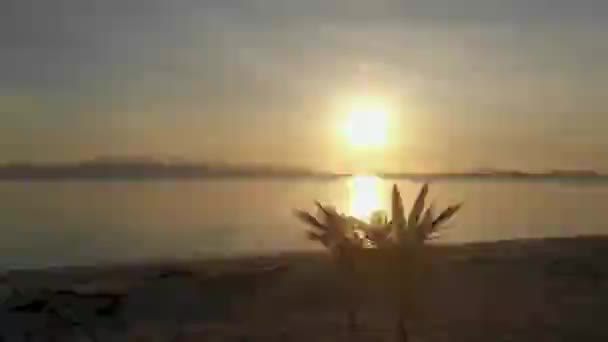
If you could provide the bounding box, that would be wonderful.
[0,0,608,171]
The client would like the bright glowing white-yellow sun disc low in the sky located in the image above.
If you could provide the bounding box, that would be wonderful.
[344,99,389,148]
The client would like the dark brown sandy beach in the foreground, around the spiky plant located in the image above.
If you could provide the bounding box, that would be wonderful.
[0,238,608,341]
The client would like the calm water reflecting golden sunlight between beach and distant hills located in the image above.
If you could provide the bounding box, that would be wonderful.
[0,177,608,268]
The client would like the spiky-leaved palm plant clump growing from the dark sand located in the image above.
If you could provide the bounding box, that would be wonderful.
[296,184,461,341]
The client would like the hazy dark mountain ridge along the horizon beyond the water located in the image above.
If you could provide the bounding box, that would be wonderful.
[0,158,608,181]
